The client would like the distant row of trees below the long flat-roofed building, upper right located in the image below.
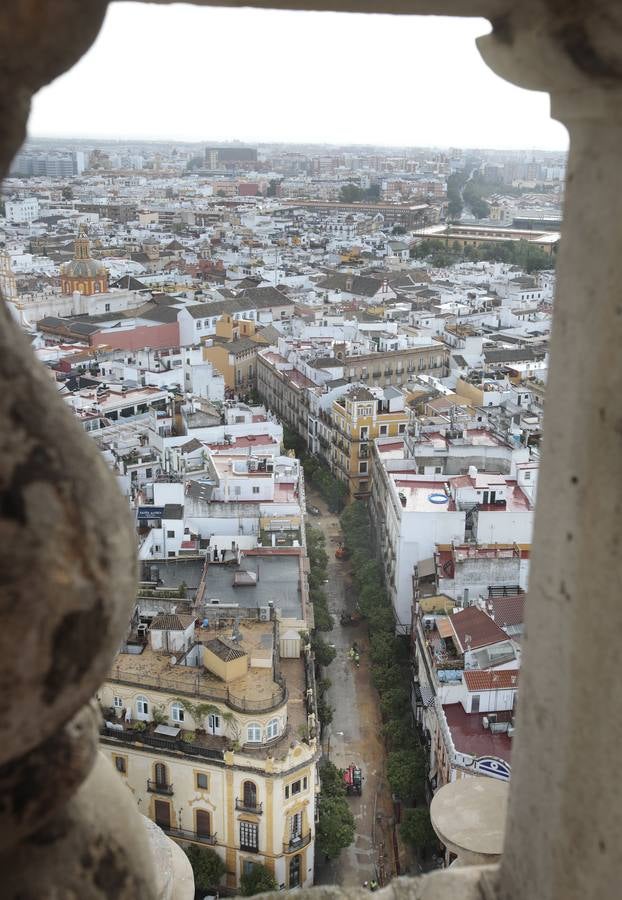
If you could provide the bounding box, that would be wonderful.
[411,238,555,272]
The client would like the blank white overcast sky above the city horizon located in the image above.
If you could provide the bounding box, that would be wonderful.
[29,3,567,149]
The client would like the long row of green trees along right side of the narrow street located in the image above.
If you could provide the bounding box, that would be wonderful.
[341,501,438,854]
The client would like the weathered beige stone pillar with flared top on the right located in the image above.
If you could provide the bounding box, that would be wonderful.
[480,8,622,900]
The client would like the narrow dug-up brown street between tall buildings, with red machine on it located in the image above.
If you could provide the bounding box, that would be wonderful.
[308,490,393,887]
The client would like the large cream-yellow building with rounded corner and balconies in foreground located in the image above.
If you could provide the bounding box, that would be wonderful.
[98,621,319,889]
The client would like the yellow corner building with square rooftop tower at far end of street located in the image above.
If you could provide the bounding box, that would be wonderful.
[331,387,408,497]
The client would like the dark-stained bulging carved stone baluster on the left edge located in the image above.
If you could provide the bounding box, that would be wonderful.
[0,0,193,900]
